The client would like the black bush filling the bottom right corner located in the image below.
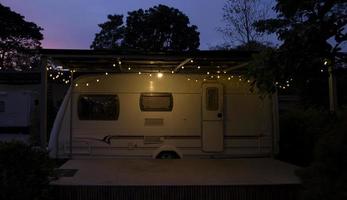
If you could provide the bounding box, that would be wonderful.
[298,113,347,200]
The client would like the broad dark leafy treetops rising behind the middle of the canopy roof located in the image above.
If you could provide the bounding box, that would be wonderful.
[91,5,200,51]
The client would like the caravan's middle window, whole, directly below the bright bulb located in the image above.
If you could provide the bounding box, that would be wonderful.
[140,93,173,111]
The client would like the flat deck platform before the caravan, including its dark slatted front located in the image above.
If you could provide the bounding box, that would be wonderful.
[51,158,300,200]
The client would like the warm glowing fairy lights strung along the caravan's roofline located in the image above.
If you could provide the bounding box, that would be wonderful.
[47,59,334,90]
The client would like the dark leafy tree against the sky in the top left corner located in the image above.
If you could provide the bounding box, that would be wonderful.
[0,4,43,69]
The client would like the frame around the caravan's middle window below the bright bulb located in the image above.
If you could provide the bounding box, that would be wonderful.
[139,92,173,112]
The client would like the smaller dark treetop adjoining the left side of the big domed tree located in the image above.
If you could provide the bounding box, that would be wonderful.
[90,15,125,49]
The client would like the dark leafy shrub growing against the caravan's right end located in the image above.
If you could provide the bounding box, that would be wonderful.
[279,107,332,166]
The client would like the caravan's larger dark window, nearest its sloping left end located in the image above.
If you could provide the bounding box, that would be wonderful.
[78,95,119,120]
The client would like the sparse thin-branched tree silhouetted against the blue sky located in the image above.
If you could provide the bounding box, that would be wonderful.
[221,0,269,47]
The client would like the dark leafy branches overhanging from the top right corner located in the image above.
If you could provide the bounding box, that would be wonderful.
[250,0,347,92]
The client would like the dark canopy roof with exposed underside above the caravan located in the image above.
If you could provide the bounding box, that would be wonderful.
[35,49,256,73]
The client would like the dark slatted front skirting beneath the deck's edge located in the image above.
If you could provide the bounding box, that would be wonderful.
[52,185,300,200]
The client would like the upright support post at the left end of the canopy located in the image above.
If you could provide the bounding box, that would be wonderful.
[40,57,47,148]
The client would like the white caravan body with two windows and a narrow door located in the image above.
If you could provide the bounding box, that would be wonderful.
[49,73,278,158]
